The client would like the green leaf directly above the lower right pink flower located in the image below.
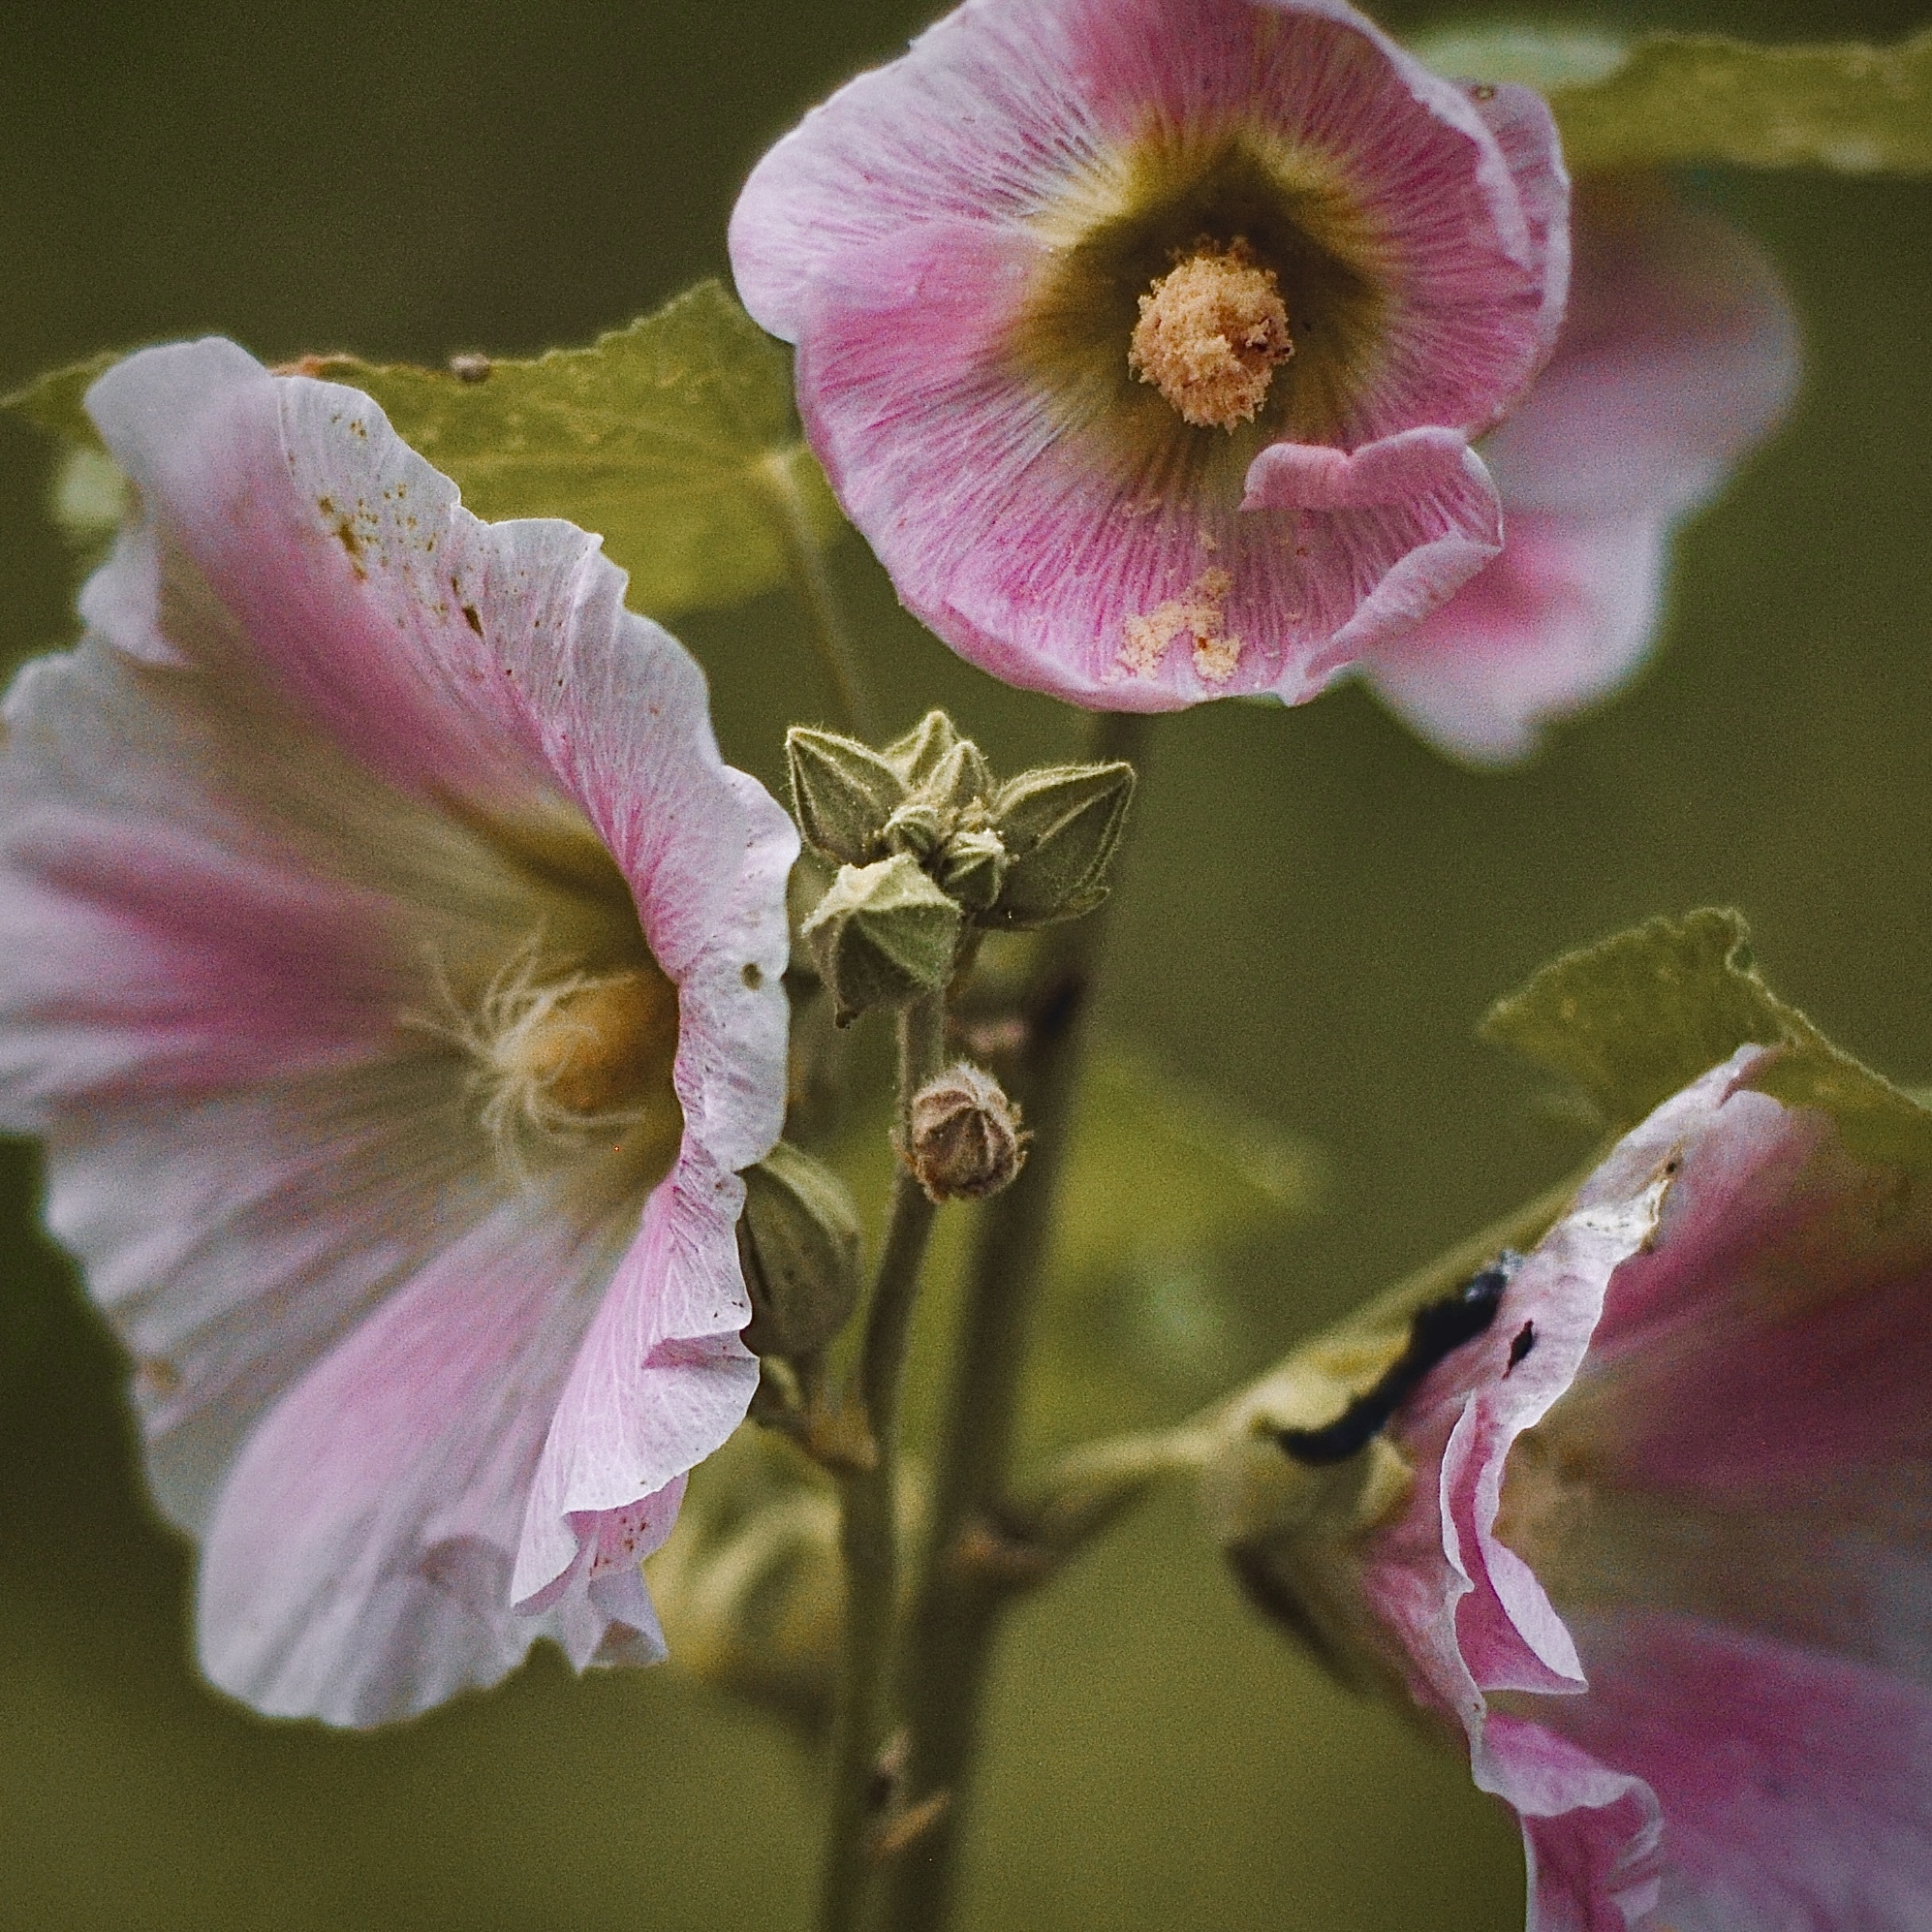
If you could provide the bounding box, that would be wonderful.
[1481,908,1932,1167]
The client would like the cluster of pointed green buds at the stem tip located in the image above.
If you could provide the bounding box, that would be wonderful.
[787,711,1134,1024]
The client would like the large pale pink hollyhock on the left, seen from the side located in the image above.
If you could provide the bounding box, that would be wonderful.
[0,342,796,1726]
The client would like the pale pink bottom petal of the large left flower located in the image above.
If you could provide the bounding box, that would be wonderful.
[197,1207,648,1726]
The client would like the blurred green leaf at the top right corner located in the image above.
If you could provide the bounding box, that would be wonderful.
[1417,27,1932,173]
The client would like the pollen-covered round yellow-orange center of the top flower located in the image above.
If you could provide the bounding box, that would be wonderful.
[1127,239,1294,431]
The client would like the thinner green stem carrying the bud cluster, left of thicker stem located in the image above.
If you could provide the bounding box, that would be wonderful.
[819,995,945,1932]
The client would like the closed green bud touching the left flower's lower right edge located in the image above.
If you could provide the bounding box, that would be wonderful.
[738,1139,859,1360]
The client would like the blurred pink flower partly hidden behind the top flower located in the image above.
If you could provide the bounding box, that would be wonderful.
[1362,179,1798,765]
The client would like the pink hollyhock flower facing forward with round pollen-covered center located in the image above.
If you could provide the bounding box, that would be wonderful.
[731,0,1569,711]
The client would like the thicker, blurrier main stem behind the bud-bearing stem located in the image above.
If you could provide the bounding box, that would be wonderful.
[885,713,1147,1932]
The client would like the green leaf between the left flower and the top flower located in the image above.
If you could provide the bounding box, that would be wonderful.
[303,282,844,618]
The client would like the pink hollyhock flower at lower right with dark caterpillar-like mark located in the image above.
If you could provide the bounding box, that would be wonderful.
[1221,1047,1932,1932]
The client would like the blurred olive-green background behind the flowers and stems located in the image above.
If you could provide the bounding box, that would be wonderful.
[0,0,1932,1932]
